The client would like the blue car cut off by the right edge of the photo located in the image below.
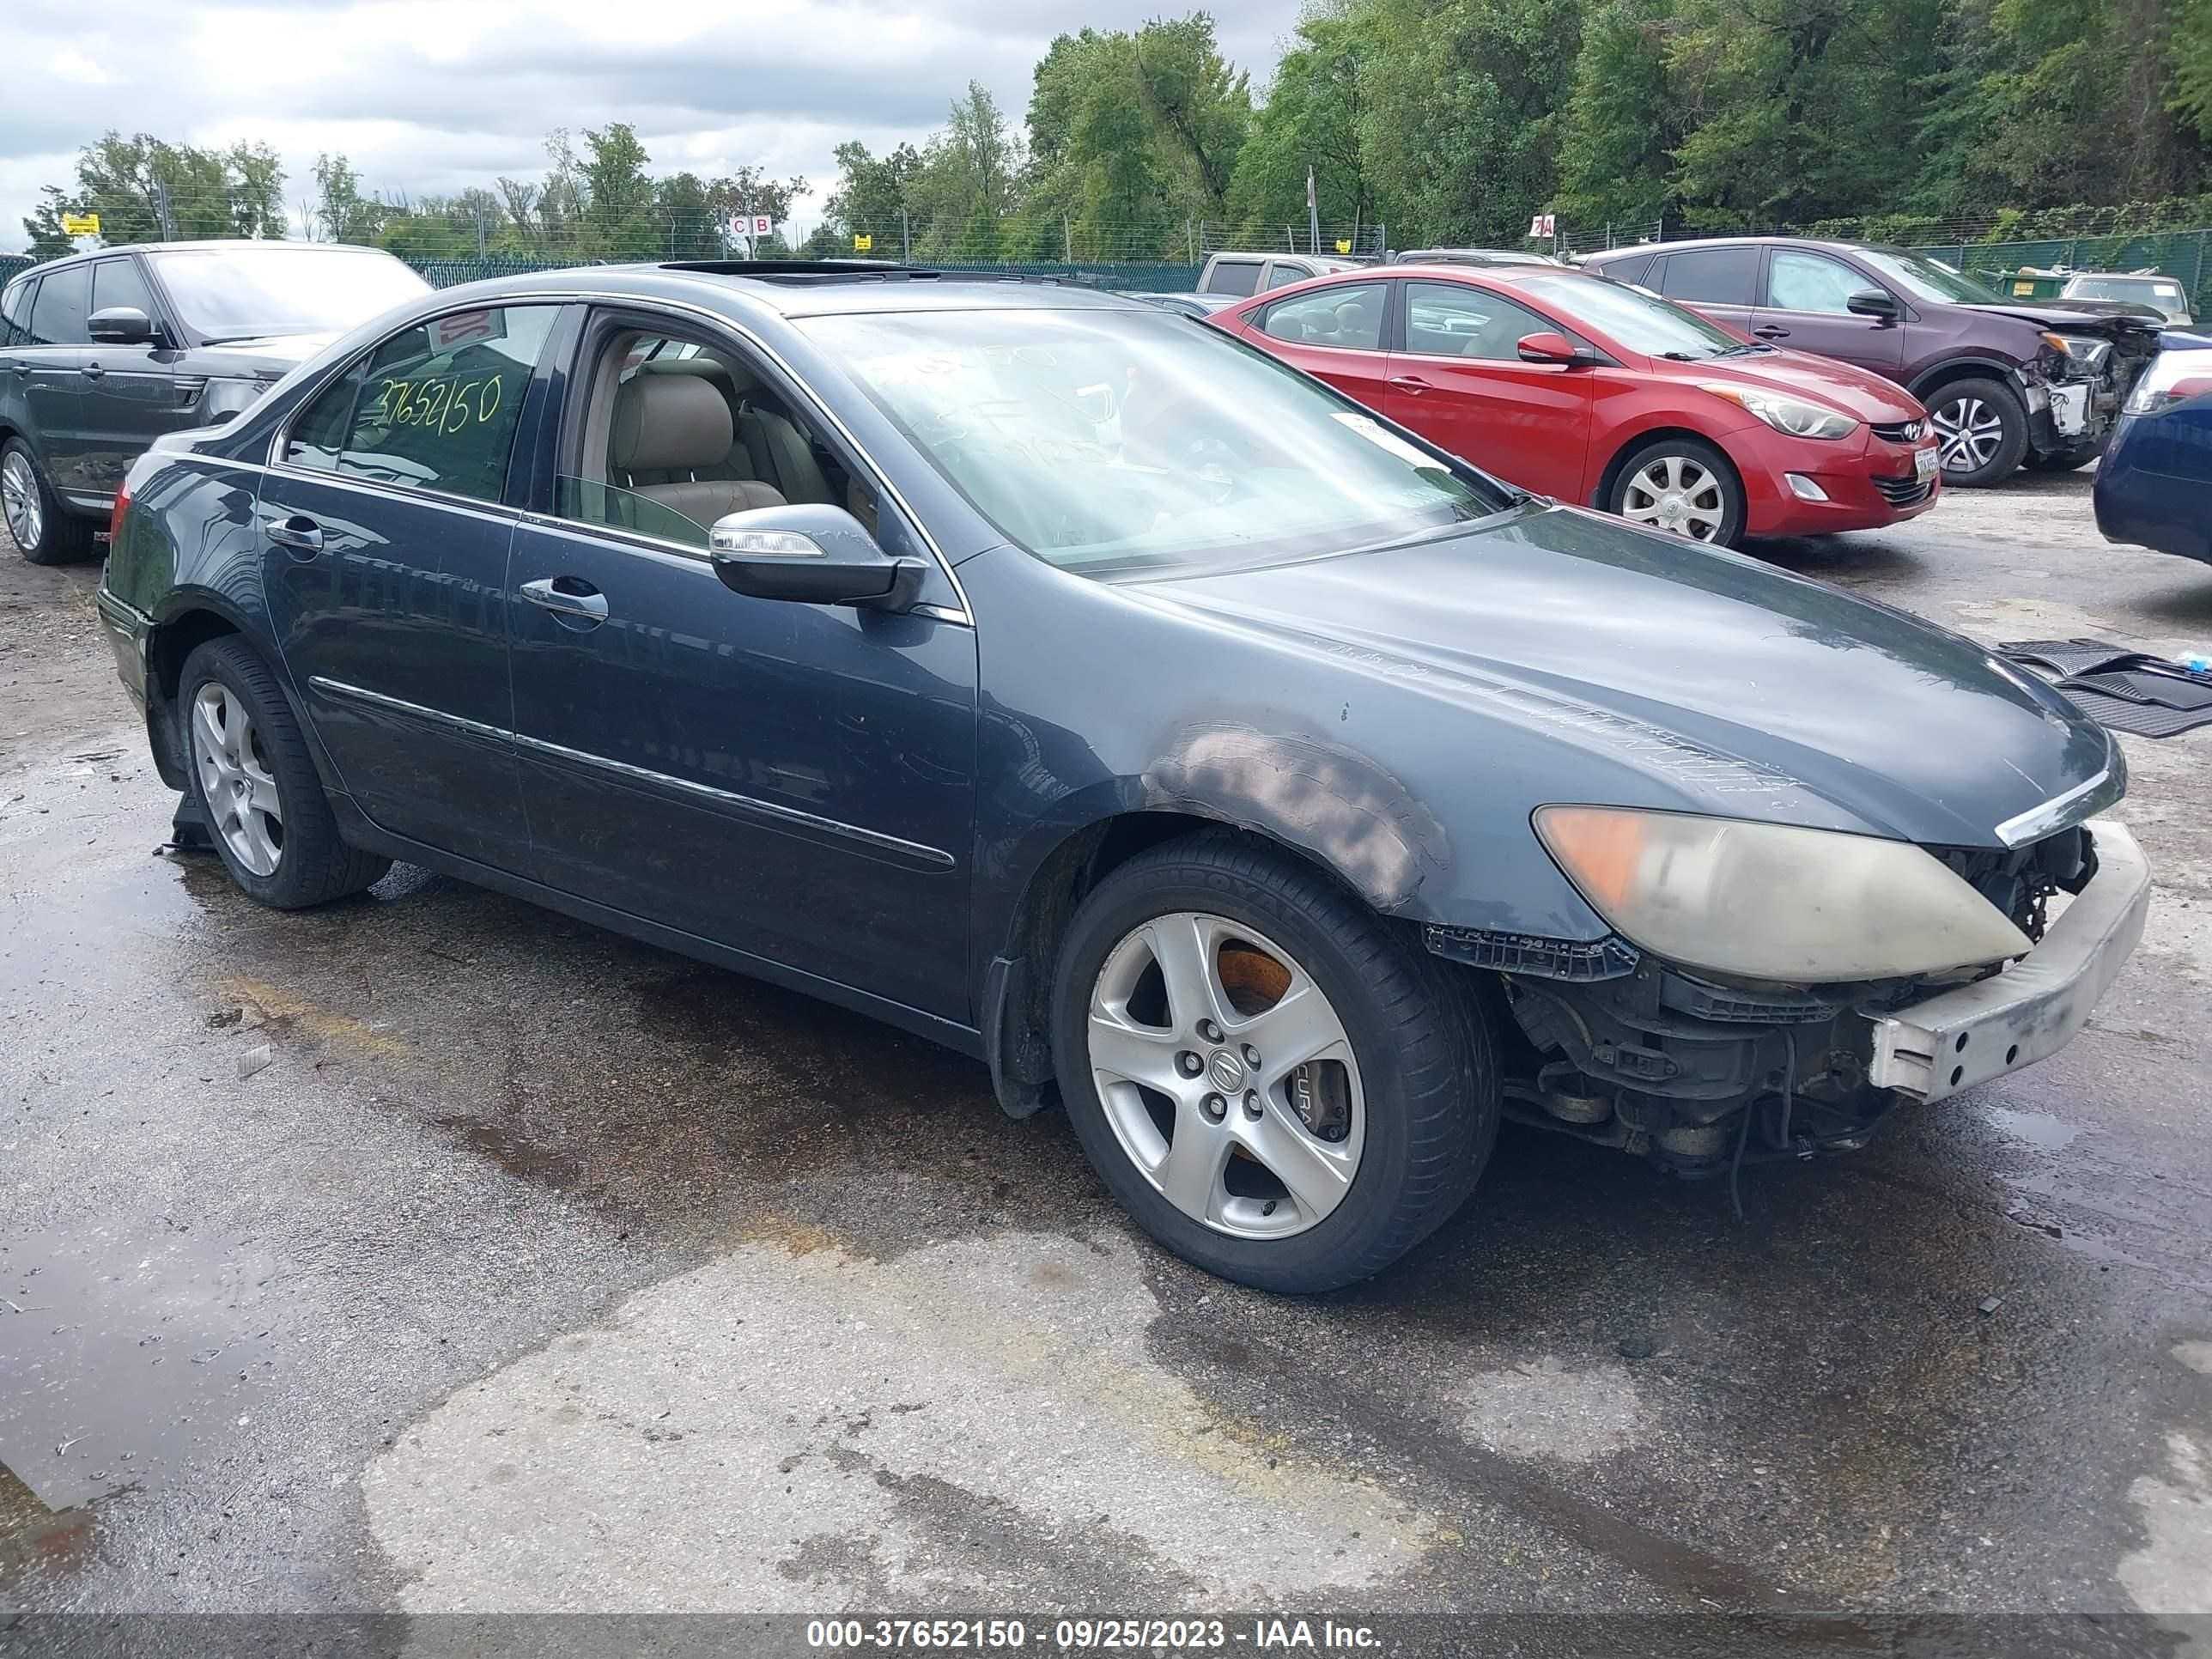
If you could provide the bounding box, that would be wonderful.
[2097,330,2212,564]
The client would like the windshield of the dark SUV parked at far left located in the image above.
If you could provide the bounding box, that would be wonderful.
[150,243,429,343]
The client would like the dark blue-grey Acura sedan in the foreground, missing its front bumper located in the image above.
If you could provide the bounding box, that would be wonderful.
[100,264,2148,1291]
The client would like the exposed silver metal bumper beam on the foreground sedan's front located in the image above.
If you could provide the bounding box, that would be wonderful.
[1867,818,2150,1102]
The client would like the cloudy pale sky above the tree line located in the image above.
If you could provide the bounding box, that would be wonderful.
[0,0,1298,250]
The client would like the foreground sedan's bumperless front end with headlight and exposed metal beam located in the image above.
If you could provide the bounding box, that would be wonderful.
[1427,810,2150,1175]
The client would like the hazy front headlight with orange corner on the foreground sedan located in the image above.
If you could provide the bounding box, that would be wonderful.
[1535,807,2028,984]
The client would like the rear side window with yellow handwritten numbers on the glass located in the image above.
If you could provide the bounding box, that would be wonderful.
[285,305,560,502]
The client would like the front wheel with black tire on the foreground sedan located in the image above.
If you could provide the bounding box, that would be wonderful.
[1053,832,1500,1294]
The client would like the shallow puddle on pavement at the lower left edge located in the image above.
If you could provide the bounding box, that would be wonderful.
[0,1221,276,1530]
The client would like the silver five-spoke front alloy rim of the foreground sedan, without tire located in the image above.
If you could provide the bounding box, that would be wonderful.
[1086,911,1367,1239]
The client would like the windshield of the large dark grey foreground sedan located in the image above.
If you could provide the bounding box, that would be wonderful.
[803,310,1517,575]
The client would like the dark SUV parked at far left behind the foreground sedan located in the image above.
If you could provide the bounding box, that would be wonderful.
[0,241,429,564]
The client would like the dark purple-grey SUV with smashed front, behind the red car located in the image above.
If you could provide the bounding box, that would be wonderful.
[1583,237,2159,487]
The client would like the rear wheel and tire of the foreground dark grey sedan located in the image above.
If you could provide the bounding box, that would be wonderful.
[177,635,392,909]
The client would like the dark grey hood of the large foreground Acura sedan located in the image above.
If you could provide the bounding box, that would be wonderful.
[1130,504,2126,848]
